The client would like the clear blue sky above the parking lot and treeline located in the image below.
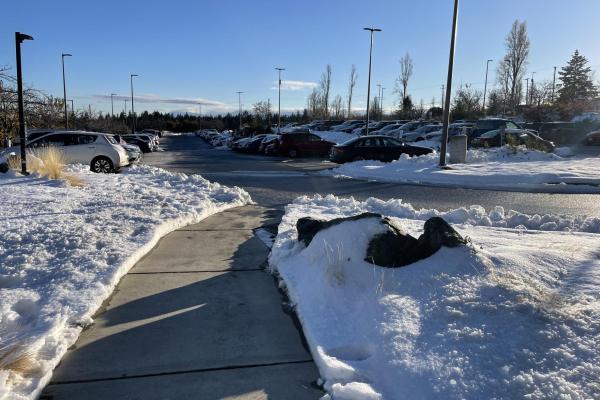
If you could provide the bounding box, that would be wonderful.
[0,0,600,113]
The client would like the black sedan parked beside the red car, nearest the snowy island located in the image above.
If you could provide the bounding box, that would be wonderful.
[329,135,433,163]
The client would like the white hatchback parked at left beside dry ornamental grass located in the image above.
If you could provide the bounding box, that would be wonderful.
[17,131,129,173]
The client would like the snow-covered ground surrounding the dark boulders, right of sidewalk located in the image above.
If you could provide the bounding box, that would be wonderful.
[270,196,600,400]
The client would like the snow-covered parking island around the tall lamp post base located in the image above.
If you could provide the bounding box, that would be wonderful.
[322,147,600,193]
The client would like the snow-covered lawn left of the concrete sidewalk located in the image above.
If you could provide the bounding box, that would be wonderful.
[0,166,251,400]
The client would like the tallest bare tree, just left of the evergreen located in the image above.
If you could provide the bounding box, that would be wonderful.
[499,20,531,111]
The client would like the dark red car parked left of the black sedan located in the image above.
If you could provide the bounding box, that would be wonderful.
[265,132,335,158]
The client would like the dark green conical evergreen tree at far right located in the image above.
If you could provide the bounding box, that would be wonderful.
[558,50,598,103]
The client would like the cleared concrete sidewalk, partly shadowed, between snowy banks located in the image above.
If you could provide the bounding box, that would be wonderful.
[41,206,323,400]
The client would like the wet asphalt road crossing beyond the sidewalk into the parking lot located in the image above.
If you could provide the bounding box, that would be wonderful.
[144,136,600,216]
